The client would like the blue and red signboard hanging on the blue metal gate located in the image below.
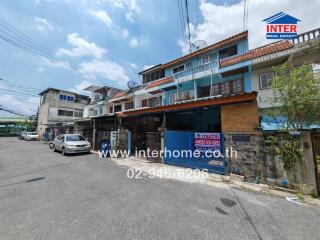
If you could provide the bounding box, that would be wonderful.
[194,133,222,152]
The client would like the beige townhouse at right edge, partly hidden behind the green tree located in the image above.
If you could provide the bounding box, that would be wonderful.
[221,28,320,193]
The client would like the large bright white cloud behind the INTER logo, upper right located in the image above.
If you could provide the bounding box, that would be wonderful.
[177,0,320,53]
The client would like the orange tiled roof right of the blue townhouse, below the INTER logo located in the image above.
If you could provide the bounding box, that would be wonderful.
[220,40,293,67]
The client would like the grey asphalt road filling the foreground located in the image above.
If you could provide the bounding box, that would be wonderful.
[0,138,320,240]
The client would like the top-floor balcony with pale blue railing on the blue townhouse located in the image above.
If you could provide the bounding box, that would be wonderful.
[174,60,219,82]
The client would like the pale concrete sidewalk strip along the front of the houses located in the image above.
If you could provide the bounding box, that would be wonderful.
[94,152,320,207]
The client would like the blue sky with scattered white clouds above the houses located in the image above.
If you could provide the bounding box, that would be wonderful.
[0,0,320,116]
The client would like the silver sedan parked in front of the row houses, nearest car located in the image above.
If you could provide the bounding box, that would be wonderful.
[53,134,91,155]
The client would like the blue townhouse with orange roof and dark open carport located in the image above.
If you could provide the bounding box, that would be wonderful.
[118,31,263,172]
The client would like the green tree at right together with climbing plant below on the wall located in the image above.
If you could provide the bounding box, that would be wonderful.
[269,62,320,182]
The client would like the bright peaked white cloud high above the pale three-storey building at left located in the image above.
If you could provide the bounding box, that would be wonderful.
[56,33,106,58]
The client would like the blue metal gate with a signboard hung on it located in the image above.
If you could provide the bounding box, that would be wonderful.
[164,131,226,175]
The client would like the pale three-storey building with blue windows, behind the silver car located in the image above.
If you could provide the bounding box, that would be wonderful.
[37,88,90,137]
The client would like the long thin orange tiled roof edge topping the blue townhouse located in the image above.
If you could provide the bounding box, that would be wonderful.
[161,31,248,68]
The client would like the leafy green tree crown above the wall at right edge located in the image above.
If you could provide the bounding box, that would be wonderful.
[271,62,320,130]
